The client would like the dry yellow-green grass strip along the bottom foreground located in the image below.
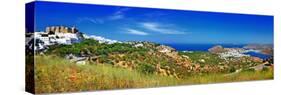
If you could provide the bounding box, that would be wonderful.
[35,56,273,93]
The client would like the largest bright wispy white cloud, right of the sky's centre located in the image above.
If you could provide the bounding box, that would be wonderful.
[140,22,186,34]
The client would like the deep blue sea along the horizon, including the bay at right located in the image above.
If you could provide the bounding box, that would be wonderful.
[164,44,271,59]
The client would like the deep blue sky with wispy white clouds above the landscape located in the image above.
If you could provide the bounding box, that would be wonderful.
[32,2,273,44]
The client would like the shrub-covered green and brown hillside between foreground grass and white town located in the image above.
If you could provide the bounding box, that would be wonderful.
[46,39,272,78]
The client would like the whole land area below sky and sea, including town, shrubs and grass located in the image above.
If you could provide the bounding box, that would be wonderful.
[26,28,274,93]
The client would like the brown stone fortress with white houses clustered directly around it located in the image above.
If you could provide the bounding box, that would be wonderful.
[26,26,84,51]
